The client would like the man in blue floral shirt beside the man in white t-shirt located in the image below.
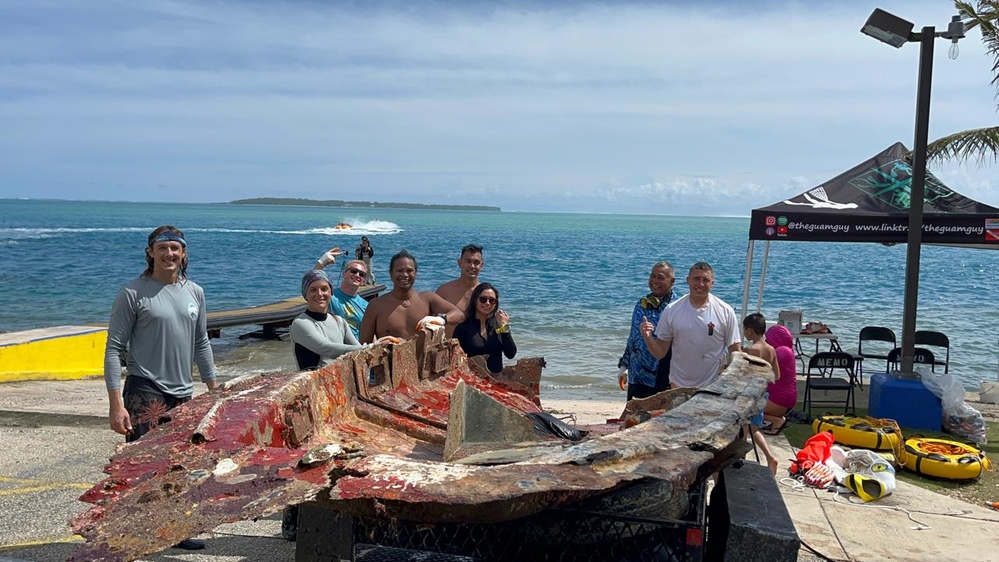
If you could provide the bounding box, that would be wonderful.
[617,261,676,400]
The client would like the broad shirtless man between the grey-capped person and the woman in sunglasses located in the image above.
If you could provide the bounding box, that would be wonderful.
[359,250,464,343]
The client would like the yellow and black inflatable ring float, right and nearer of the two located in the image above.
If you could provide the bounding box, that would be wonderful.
[900,437,992,480]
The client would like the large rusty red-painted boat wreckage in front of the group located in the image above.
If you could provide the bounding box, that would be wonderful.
[70,328,772,561]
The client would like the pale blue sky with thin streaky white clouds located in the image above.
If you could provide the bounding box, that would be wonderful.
[0,0,999,215]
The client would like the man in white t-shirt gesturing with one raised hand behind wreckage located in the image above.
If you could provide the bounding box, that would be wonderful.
[640,262,742,388]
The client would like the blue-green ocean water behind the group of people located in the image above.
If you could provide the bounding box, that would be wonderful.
[0,200,999,399]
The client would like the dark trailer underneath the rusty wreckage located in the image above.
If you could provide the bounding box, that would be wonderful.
[295,463,799,562]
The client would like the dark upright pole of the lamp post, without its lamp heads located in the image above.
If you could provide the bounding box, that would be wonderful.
[902,26,936,374]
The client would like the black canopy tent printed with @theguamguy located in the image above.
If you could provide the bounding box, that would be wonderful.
[742,142,999,318]
